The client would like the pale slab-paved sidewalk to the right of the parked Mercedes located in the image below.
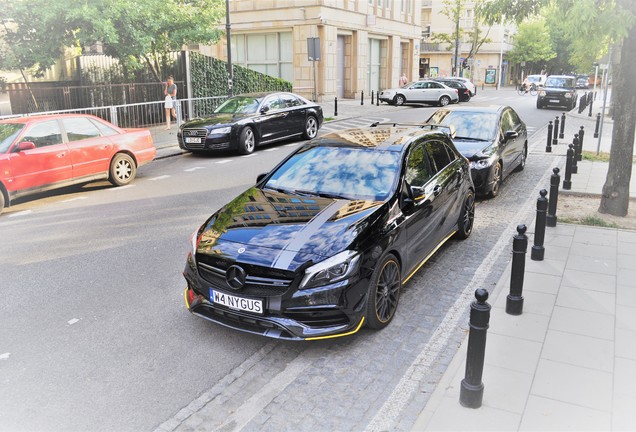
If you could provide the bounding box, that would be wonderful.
[413,93,636,431]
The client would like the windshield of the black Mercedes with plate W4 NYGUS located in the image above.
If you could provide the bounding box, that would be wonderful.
[265,147,400,201]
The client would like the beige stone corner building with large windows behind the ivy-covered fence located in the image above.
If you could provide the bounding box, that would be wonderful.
[200,0,421,101]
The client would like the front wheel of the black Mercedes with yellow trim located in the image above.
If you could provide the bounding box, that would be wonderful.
[366,254,402,330]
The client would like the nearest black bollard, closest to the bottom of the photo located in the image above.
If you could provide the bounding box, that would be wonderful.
[459,288,490,408]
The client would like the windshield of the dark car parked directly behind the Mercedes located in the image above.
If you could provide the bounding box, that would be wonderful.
[428,111,498,141]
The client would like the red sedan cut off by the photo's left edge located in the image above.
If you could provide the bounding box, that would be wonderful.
[0,114,157,212]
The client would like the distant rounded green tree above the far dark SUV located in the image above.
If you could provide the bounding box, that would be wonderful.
[507,20,556,71]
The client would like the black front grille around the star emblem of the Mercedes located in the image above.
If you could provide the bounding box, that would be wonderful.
[197,255,293,297]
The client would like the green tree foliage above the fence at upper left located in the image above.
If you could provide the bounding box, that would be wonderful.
[0,0,225,81]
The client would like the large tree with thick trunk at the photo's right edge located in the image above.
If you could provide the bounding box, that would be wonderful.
[481,0,636,216]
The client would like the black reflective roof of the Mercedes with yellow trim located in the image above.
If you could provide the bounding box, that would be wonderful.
[306,124,449,152]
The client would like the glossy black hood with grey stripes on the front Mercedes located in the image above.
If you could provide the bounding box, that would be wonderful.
[197,187,383,271]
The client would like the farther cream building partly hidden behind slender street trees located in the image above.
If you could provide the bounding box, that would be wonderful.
[418,0,516,86]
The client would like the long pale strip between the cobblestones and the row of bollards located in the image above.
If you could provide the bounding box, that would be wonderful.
[365,157,551,432]
